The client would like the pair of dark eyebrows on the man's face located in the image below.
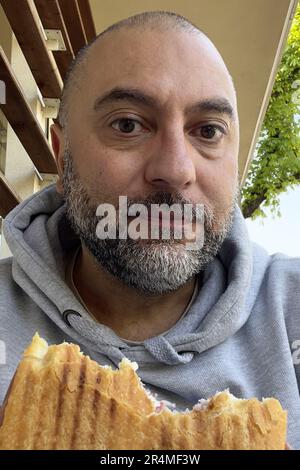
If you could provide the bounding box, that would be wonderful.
[94,87,234,119]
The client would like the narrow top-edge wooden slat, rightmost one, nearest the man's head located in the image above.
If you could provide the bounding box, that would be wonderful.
[58,0,87,55]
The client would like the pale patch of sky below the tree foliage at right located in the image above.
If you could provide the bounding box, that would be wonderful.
[246,185,300,257]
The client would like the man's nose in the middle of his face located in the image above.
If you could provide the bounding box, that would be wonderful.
[145,125,196,190]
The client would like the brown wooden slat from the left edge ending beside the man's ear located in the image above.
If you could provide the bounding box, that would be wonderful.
[0,47,57,173]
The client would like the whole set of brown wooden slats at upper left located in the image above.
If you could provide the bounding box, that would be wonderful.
[0,0,96,217]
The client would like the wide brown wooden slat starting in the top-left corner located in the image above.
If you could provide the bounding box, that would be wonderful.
[0,0,62,98]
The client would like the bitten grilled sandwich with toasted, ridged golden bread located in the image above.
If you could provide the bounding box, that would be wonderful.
[0,333,287,450]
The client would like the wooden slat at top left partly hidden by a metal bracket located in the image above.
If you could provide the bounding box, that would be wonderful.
[34,0,74,80]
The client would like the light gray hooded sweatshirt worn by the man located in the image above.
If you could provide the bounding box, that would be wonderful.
[0,185,300,448]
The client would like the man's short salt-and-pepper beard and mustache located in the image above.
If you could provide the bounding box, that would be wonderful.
[63,150,237,296]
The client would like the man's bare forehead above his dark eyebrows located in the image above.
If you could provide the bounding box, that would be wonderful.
[72,29,234,116]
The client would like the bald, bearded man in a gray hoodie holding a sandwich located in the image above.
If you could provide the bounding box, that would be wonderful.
[0,12,300,447]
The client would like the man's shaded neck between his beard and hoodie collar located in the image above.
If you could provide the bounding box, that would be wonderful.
[73,242,195,341]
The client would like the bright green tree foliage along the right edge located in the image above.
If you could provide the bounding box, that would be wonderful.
[241,5,300,218]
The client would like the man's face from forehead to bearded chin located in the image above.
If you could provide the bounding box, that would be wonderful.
[58,29,239,293]
